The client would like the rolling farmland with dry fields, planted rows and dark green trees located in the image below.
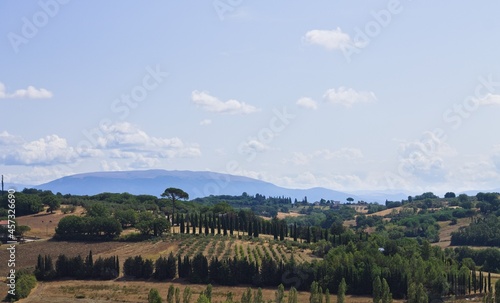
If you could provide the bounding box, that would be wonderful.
[0,189,500,302]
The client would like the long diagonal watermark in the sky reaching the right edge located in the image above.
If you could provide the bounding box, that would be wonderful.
[385,74,500,189]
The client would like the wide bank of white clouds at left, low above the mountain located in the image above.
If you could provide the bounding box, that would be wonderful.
[0,122,201,168]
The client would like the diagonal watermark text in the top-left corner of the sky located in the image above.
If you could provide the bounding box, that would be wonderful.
[7,0,70,54]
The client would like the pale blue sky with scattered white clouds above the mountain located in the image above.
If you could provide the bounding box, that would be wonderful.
[0,0,500,195]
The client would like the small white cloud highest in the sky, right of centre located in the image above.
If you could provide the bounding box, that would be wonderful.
[304,27,365,50]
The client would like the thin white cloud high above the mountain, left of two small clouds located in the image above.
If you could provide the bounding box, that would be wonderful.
[191,91,259,114]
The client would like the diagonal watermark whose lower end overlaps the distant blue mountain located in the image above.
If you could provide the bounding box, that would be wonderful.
[189,107,296,197]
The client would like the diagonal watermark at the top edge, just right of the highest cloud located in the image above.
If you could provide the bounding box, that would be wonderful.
[341,0,412,62]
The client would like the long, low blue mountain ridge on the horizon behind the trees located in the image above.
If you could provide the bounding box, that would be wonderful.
[34,169,360,202]
